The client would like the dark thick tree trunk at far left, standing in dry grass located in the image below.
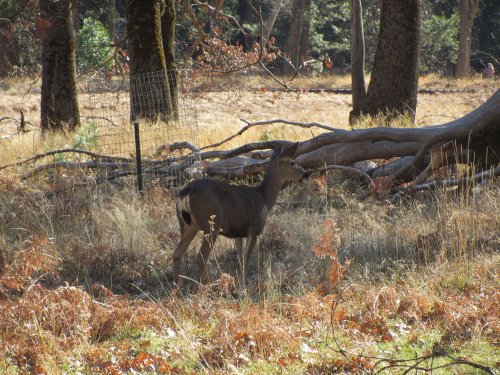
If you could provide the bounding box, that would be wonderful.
[39,0,80,132]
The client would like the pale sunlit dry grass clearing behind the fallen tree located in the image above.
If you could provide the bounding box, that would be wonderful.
[0,75,498,150]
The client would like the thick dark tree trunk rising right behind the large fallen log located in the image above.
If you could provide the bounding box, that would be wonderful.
[352,0,420,120]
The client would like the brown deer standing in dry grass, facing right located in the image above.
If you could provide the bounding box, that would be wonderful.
[173,142,305,286]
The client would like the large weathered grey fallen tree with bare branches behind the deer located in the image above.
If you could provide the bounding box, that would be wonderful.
[0,90,500,200]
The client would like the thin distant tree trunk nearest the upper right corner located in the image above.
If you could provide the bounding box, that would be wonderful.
[457,0,479,77]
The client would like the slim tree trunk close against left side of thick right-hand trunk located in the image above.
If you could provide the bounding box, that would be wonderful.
[349,0,366,122]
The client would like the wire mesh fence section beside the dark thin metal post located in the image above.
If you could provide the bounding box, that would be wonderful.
[76,70,199,189]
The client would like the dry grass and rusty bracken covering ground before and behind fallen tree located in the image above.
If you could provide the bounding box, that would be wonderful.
[0,77,500,374]
